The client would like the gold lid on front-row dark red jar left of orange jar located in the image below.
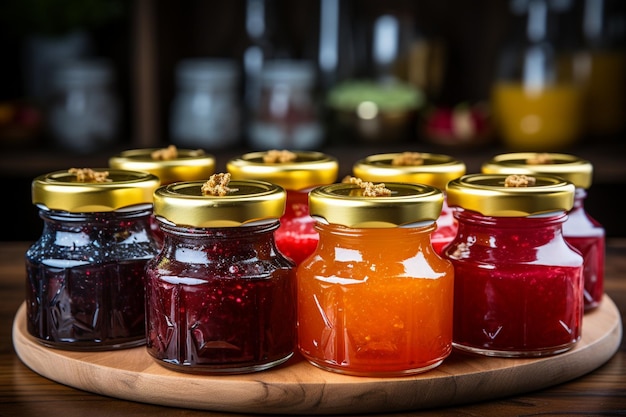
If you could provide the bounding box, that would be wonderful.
[154,180,286,227]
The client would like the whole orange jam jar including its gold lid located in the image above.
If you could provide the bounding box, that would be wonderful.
[297,183,454,377]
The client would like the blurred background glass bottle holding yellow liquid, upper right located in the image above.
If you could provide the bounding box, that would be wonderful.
[492,0,583,151]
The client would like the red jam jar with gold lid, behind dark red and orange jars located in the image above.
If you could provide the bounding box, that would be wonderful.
[226,150,339,265]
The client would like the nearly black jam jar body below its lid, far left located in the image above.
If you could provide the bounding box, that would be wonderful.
[26,206,158,351]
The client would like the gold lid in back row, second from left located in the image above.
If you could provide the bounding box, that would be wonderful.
[226,151,339,190]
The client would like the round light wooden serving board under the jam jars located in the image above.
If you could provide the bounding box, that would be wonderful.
[13,296,622,415]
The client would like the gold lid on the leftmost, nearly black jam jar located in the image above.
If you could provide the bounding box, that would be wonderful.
[31,168,160,213]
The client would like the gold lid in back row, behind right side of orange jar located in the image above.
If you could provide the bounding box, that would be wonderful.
[352,152,466,190]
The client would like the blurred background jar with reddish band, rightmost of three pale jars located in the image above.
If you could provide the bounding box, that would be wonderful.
[248,59,324,149]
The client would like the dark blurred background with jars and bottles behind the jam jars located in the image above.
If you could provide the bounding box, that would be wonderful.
[0,0,626,240]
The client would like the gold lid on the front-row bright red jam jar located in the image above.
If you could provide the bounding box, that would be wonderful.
[446,174,575,217]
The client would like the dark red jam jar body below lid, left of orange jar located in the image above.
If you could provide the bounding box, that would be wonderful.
[146,220,296,374]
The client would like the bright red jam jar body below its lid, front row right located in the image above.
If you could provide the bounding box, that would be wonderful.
[445,209,583,357]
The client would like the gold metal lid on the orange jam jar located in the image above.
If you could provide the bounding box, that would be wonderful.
[309,183,443,228]
